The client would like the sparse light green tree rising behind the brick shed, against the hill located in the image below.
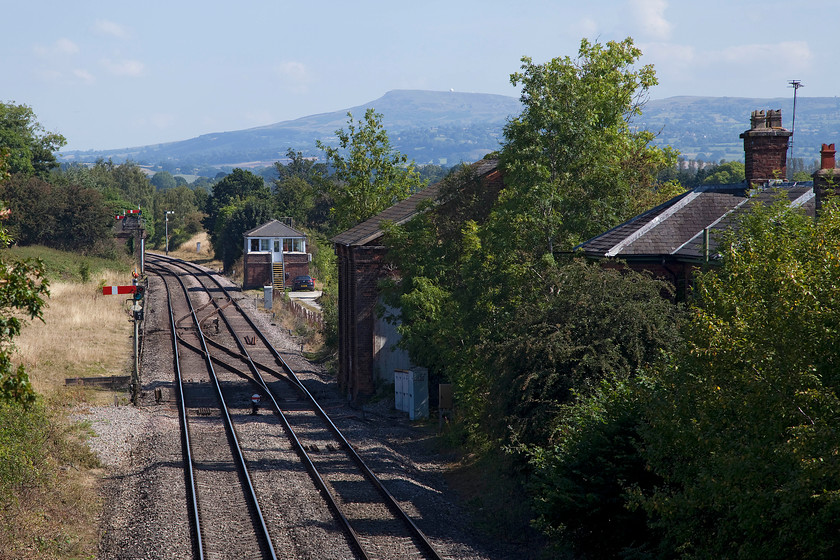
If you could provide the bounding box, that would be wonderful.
[316,109,424,231]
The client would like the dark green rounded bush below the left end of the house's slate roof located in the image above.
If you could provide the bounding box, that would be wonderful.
[492,261,680,444]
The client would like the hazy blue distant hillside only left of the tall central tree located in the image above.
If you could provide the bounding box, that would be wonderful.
[59,90,521,172]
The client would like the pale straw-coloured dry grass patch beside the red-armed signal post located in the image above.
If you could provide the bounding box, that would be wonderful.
[16,271,133,396]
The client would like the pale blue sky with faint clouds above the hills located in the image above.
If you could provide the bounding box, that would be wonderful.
[0,0,840,151]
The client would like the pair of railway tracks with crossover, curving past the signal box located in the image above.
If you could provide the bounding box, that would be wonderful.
[147,255,441,559]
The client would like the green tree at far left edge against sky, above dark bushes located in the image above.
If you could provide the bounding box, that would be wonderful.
[0,102,67,178]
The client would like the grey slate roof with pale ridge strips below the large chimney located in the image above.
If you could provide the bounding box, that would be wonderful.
[575,182,815,261]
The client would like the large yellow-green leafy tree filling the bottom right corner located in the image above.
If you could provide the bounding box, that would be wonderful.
[641,199,840,559]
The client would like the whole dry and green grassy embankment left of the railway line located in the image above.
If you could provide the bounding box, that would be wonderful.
[0,247,138,559]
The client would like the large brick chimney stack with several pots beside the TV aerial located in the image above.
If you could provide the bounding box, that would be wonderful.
[741,109,791,186]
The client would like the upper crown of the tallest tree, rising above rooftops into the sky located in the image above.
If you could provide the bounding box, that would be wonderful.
[499,38,675,256]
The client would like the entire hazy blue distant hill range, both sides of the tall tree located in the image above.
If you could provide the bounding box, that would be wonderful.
[59,90,840,176]
